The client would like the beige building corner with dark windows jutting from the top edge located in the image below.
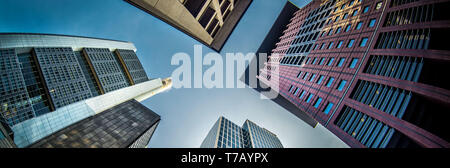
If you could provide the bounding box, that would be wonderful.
[125,0,252,52]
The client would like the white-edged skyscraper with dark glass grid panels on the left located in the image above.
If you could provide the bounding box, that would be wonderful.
[0,33,171,147]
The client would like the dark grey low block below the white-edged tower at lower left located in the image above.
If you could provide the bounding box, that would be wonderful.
[30,100,160,148]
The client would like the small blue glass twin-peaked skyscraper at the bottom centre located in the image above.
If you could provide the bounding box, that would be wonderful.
[200,116,283,148]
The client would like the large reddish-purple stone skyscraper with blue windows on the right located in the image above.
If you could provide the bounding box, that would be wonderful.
[247,0,450,148]
